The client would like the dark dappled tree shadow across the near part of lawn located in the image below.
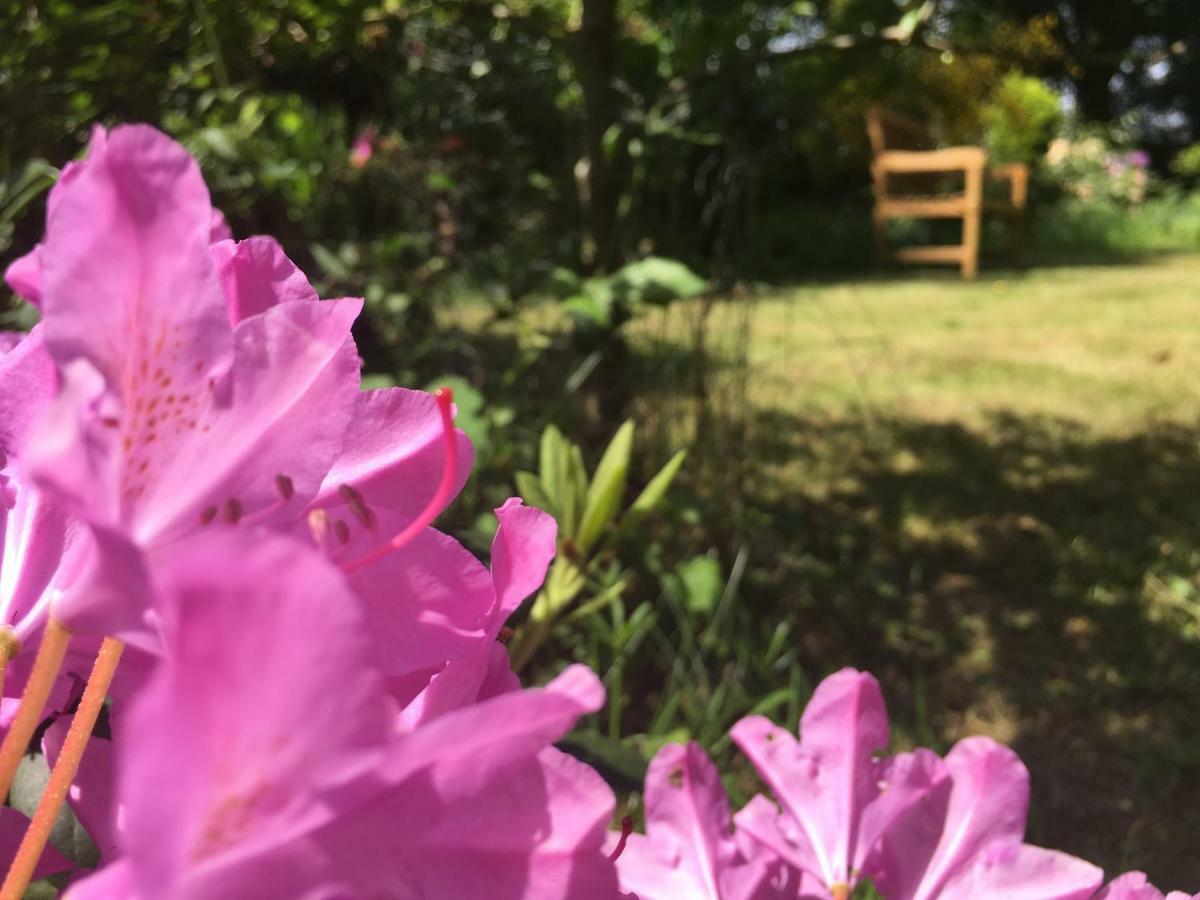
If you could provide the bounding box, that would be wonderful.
[748,415,1200,887]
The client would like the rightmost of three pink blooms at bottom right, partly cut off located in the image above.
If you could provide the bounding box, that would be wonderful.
[875,737,1103,900]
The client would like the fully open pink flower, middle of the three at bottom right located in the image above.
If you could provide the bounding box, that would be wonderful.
[730,668,949,898]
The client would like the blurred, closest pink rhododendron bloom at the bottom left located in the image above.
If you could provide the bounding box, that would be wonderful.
[68,532,617,900]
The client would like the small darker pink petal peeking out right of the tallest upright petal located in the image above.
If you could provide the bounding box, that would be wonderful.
[210,236,317,325]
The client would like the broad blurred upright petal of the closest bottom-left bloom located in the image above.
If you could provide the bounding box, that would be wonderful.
[120,532,395,898]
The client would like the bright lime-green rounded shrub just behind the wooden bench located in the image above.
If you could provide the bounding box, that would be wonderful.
[979,71,1062,164]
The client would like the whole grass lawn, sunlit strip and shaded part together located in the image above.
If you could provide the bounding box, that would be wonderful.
[635,257,1200,888]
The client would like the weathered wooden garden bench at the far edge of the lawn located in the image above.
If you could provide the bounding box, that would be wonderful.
[866,107,1030,278]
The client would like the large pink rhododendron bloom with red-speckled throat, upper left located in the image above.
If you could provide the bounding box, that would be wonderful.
[9,126,469,647]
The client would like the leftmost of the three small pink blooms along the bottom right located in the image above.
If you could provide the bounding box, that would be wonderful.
[617,743,797,900]
